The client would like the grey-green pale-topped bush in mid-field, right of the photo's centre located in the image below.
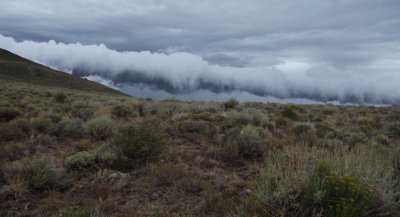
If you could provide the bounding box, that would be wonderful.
[222,125,266,160]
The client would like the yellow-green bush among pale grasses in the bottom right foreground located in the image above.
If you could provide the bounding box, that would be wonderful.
[301,162,373,217]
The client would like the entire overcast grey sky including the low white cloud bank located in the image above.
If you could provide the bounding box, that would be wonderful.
[0,0,400,105]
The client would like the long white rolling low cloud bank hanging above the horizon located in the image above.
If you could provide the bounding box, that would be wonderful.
[0,35,400,105]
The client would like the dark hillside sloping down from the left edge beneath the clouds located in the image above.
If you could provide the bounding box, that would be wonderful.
[0,48,125,95]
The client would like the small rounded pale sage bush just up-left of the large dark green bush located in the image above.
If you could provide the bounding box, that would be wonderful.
[84,117,116,140]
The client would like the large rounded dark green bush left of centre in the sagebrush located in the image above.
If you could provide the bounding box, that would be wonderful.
[113,125,165,169]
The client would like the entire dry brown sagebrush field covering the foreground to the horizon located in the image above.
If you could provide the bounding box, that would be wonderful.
[0,80,400,217]
